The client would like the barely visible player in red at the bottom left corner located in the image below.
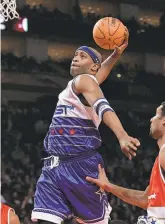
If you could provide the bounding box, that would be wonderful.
[1,203,20,224]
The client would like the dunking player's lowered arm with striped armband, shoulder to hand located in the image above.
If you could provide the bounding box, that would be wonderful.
[73,75,140,159]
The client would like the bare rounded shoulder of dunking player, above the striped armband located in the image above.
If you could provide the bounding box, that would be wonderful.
[74,74,98,93]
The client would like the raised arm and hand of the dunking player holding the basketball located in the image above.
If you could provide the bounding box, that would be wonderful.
[96,28,129,84]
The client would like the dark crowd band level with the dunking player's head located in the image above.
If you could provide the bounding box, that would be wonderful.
[1,53,163,83]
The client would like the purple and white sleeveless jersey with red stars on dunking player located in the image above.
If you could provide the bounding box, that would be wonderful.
[44,75,101,156]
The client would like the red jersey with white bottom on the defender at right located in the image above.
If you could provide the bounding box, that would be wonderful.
[147,151,165,219]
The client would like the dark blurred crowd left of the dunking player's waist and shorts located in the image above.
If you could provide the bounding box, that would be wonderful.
[1,103,44,224]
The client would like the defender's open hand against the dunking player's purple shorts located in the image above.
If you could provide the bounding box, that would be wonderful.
[86,164,110,190]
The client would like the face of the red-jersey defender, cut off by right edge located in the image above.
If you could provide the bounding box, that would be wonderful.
[150,106,165,139]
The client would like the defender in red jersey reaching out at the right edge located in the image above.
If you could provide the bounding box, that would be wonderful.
[86,102,165,224]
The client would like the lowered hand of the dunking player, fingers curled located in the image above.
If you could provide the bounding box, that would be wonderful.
[119,135,140,160]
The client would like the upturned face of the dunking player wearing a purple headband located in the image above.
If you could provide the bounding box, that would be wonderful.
[70,50,95,77]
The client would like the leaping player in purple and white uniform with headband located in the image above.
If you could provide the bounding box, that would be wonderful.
[32,28,140,224]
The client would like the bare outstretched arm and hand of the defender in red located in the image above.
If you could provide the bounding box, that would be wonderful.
[86,164,149,209]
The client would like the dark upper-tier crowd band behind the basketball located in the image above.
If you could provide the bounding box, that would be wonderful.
[5,3,165,52]
